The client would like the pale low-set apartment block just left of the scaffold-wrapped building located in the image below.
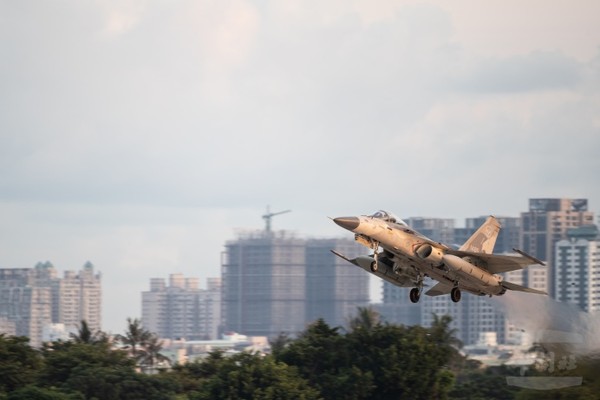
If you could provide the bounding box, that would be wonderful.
[142,274,221,340]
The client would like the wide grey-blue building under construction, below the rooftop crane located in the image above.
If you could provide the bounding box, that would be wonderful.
[222,231,368,337]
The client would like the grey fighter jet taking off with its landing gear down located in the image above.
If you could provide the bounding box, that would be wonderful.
[331,211,547,303]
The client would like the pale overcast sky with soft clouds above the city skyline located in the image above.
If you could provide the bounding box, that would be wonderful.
[0,0,600,332]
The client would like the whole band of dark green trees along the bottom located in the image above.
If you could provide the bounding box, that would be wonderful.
[15,314,600,400]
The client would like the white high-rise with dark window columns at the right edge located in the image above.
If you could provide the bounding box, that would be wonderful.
[554,225,600,312]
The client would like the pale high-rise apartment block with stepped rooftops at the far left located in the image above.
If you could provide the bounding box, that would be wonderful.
[0,262,101,346]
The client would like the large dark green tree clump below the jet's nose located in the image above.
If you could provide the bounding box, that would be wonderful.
[274,316,456,400]
